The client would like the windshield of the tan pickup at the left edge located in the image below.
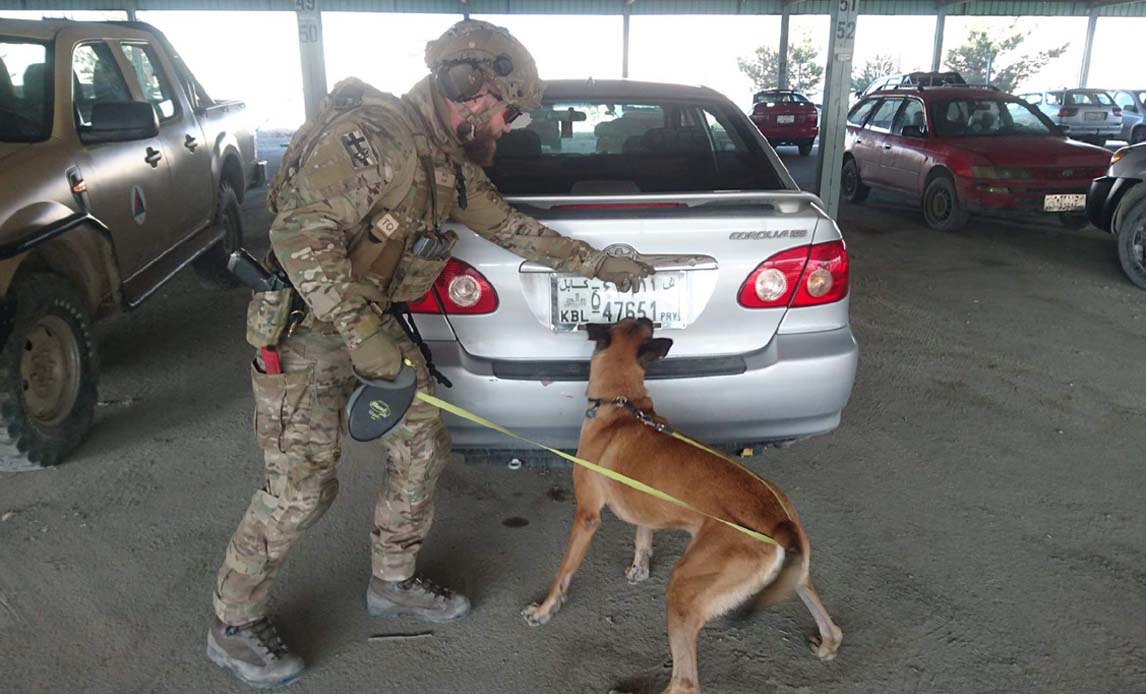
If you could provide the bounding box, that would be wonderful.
[0,37,52,142]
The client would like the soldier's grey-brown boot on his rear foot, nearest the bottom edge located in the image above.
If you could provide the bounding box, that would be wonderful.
[207,617,306,689]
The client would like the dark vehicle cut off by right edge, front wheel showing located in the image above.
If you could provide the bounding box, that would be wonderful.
[1086,142,1146,290]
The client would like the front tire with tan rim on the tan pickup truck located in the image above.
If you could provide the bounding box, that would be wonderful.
[0,274,99,472]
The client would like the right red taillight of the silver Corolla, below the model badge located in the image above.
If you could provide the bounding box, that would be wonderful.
[738,240,848,308]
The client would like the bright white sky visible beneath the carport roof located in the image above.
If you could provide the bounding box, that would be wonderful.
[0,10,1146,128]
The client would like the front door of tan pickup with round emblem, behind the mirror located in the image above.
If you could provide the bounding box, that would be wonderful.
[68,41,178,282]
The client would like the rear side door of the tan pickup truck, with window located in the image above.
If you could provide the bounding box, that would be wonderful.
[119,41,214,241]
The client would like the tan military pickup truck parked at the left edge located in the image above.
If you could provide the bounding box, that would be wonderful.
[0,21,259,471]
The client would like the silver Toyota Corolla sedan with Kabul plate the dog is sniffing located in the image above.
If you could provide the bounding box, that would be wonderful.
[411,80,857,455]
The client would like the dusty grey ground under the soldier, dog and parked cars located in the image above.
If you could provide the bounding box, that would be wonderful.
[0,144,1146,694]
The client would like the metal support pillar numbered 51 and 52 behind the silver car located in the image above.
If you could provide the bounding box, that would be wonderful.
[816,0,860,218]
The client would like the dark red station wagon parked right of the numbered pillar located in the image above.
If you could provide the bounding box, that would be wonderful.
[842,87,1110,230]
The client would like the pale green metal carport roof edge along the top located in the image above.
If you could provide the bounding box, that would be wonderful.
[0,0,1146,17]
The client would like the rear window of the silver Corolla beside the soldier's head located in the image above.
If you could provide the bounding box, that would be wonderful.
[487,100,784,196]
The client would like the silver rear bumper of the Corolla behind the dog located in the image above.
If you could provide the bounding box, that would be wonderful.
[430,328,858,449]
